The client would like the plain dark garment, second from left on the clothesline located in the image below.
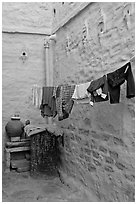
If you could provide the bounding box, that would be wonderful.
[40,87,57,117]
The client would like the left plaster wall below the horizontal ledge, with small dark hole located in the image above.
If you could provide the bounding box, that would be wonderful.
[2,33,46,155]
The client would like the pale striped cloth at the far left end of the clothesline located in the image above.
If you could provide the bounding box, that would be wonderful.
[32,84,42,108]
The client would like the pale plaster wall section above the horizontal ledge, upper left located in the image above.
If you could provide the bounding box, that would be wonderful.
[2,2,52,34]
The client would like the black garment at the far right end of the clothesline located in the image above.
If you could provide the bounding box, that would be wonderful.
[107,62,135,104]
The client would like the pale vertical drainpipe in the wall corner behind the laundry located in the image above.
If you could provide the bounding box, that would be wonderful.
[44,34,56,124]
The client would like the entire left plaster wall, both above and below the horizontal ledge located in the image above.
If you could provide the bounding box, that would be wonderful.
[2,2,52,158]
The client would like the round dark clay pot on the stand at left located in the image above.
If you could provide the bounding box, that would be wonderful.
[5,119,24,137]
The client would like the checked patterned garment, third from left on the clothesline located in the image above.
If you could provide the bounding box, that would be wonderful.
[56,84,75,121]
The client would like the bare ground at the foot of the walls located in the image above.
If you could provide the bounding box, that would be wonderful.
[2,171,97,202]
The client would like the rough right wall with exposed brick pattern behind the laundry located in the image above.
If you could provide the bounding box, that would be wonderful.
[54,2,135,202]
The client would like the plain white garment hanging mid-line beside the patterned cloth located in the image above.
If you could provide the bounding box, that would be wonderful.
[72,82,91,100]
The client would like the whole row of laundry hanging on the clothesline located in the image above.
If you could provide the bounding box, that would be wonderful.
[33,56,135,120]
